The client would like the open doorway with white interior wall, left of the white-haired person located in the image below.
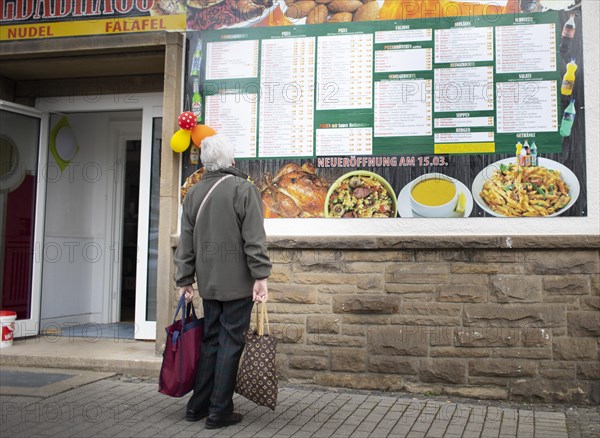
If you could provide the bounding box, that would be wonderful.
[41,111,142,338]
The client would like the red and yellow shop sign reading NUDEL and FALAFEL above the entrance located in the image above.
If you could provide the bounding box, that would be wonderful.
[0,0,186,41]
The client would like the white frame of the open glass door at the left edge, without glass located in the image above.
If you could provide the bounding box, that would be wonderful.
[0,99,50,338]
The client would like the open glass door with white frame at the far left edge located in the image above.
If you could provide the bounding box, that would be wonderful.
[0,100,48,337]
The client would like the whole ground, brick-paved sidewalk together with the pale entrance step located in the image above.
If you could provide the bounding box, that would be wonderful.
[0,336,600,438]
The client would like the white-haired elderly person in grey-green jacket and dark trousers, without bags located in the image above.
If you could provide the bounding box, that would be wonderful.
[175,134,271,429]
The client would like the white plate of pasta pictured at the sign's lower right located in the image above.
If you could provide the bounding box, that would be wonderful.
[472,158,580,217]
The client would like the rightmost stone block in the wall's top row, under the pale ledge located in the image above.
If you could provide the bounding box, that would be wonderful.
[525,250,600,275]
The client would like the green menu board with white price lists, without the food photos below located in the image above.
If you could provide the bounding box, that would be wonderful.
[202,12,562,159]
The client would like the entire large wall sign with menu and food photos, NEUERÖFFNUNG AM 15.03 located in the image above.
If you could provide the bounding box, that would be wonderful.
[182,0,587,218]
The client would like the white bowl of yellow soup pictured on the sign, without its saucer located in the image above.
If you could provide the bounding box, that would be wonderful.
[409,173,459,217]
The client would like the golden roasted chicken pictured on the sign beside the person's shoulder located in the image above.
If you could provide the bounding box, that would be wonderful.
[259,162,329,218]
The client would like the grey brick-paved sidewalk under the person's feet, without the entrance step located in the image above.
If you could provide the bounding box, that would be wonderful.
[0,367,600,438]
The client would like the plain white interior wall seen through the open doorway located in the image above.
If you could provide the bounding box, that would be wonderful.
[41,112,141,327]
